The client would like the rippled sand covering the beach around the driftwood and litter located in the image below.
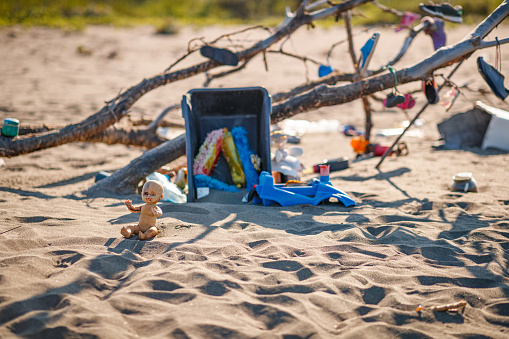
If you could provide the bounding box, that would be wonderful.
[0,24,509,338]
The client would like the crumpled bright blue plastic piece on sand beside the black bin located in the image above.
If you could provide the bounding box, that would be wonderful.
[254,171,355,207]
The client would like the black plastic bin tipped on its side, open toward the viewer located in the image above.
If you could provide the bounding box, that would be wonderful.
[182,87,271,202]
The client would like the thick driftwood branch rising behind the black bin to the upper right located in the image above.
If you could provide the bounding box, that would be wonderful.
[85,0,509,193]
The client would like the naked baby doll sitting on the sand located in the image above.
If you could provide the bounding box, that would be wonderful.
[120,180,164,240]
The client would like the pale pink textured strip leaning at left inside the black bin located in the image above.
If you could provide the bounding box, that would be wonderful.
[193,128,223,176]
